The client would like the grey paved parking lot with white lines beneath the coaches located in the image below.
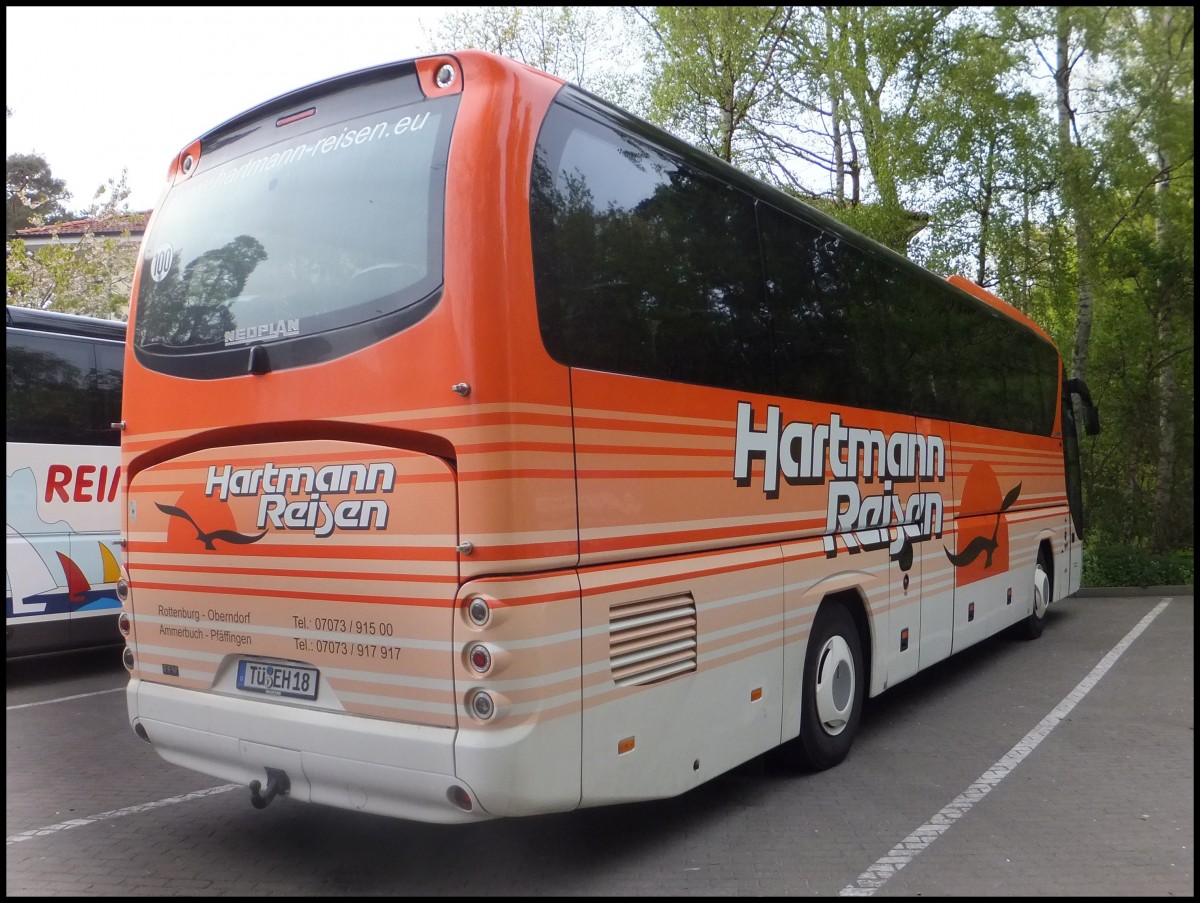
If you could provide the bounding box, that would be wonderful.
[6,588,1195,897]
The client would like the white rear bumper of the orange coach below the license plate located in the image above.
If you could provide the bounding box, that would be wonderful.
[126,678,494,824]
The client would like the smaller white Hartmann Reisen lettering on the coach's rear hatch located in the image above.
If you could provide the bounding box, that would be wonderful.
[204,461,396,538]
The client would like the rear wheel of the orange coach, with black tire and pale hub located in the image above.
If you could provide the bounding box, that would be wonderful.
[790,602,866,771]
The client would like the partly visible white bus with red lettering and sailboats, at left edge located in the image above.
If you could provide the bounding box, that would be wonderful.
[5,306,125,658]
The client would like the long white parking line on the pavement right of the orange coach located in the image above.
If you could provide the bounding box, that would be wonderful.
[839,598,1171,897]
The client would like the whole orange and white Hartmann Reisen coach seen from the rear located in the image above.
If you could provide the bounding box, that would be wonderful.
[120,52,1098,823]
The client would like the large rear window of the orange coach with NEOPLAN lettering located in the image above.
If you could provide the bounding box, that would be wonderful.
[133,71,457,378]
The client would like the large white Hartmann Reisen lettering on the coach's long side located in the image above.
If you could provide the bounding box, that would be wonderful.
[733,401,946,558]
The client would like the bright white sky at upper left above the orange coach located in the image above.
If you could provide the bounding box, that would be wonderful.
[5,5,461,210]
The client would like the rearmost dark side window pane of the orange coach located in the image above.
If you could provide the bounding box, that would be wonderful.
[530,107,774,391]
